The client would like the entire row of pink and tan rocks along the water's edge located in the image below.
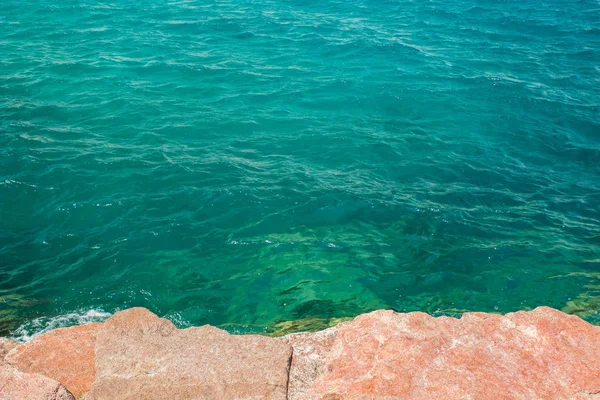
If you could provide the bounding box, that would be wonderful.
[0,307,600,400]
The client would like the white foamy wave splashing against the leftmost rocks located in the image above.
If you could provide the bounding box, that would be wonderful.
[12,310,111,342]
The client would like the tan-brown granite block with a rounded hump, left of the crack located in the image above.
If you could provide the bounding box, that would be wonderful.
[91,308,292,400]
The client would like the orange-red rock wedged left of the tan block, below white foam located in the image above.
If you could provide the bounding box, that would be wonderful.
[6,323,102,397]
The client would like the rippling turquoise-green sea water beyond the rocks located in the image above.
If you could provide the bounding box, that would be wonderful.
[0,0,600,337]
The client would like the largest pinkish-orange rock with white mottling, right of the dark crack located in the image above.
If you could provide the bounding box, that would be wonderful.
[285,307,600,400]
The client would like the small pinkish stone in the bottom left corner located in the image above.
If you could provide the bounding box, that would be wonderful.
[0,364,75,400]
